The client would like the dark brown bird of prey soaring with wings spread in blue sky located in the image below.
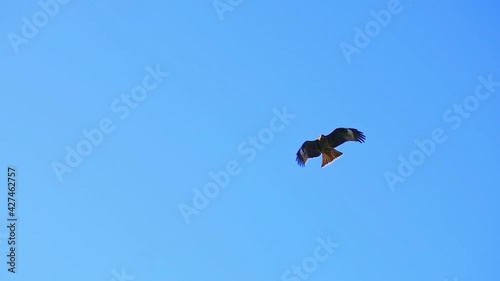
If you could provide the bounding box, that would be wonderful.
[296,128,365,168]
